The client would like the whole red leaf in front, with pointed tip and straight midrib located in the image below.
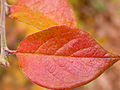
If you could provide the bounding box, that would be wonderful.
[17,26,120,89]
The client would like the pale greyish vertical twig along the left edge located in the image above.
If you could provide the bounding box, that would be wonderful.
[0,0,9,66]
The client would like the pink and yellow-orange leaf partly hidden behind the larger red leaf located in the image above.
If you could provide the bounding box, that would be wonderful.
[10,0,76,29]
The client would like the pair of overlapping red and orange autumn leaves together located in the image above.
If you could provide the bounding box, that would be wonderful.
[10,0,120,90]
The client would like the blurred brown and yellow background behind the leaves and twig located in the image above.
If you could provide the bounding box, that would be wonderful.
[0,0,120,90]
